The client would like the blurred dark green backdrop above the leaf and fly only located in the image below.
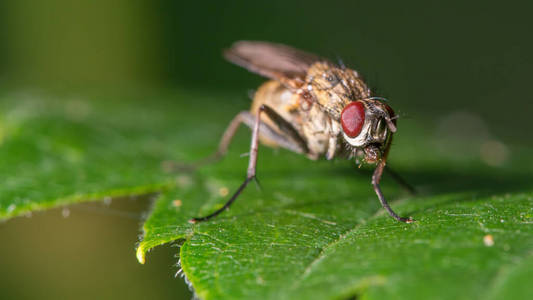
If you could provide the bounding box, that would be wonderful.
[0,0,533,136]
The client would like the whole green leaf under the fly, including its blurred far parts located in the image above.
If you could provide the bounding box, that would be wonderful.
[0,91,533,299]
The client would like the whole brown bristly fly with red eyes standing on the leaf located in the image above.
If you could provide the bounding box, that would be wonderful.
[190,41,413,223]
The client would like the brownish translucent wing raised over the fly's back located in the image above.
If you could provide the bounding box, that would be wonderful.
[224,41,324,87]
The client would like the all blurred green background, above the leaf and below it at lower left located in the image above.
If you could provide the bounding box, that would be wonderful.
[0,0,533,299]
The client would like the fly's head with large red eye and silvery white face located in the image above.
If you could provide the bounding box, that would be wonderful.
[340,98,396,163]
